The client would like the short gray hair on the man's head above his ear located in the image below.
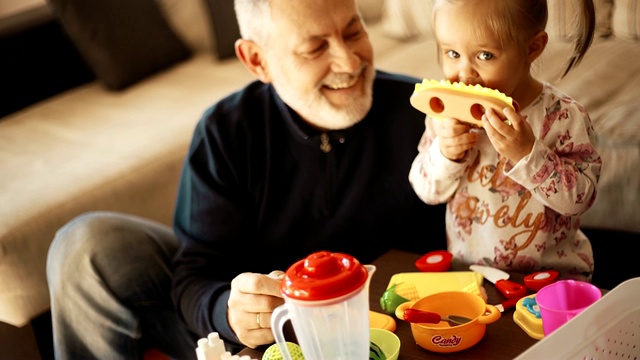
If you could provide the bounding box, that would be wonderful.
[235,0,271,45]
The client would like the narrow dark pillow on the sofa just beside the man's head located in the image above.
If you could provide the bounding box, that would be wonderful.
[205,0,240,59]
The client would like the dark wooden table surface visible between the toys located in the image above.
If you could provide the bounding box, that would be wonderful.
[238,250,537,360]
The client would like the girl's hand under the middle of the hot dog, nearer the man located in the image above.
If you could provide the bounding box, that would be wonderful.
[435,119,479,161]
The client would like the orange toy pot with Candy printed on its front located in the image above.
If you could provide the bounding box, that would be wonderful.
[396,291,501,353]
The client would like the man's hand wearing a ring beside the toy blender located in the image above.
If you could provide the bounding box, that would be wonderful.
[227,271,284,348]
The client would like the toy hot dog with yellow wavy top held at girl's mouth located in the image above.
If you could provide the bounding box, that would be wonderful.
[410,79,519,127]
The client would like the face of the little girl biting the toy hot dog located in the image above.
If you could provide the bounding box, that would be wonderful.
[435,2,530,100]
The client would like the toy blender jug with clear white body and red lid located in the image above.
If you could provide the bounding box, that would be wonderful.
[271,251,376,360]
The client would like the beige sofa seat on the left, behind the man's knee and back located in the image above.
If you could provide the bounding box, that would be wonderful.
[0,52,253,326]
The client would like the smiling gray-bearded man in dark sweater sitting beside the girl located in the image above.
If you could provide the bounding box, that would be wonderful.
[47,0,446,359]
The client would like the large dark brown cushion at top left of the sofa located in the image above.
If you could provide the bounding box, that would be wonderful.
[50,0,191,90]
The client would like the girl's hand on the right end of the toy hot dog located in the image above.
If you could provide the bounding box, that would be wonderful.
[482,108,535,163]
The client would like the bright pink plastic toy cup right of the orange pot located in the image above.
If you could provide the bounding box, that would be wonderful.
[536,280,602,336]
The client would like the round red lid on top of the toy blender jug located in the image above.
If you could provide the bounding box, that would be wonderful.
[280,251,369,301]
